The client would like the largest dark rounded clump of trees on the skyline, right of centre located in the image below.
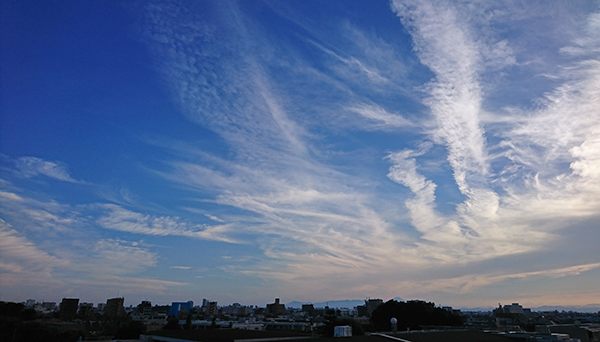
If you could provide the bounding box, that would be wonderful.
[371,300,463,331]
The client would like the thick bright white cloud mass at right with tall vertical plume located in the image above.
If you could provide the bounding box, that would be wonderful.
[388,1,598,268]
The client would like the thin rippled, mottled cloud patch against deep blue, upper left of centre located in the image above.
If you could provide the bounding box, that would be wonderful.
[145,1,307,155]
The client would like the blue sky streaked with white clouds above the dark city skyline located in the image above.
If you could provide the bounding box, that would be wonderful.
[0,0,600,307]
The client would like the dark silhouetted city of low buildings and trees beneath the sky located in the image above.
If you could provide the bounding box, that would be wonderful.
[0,297,600,342]
